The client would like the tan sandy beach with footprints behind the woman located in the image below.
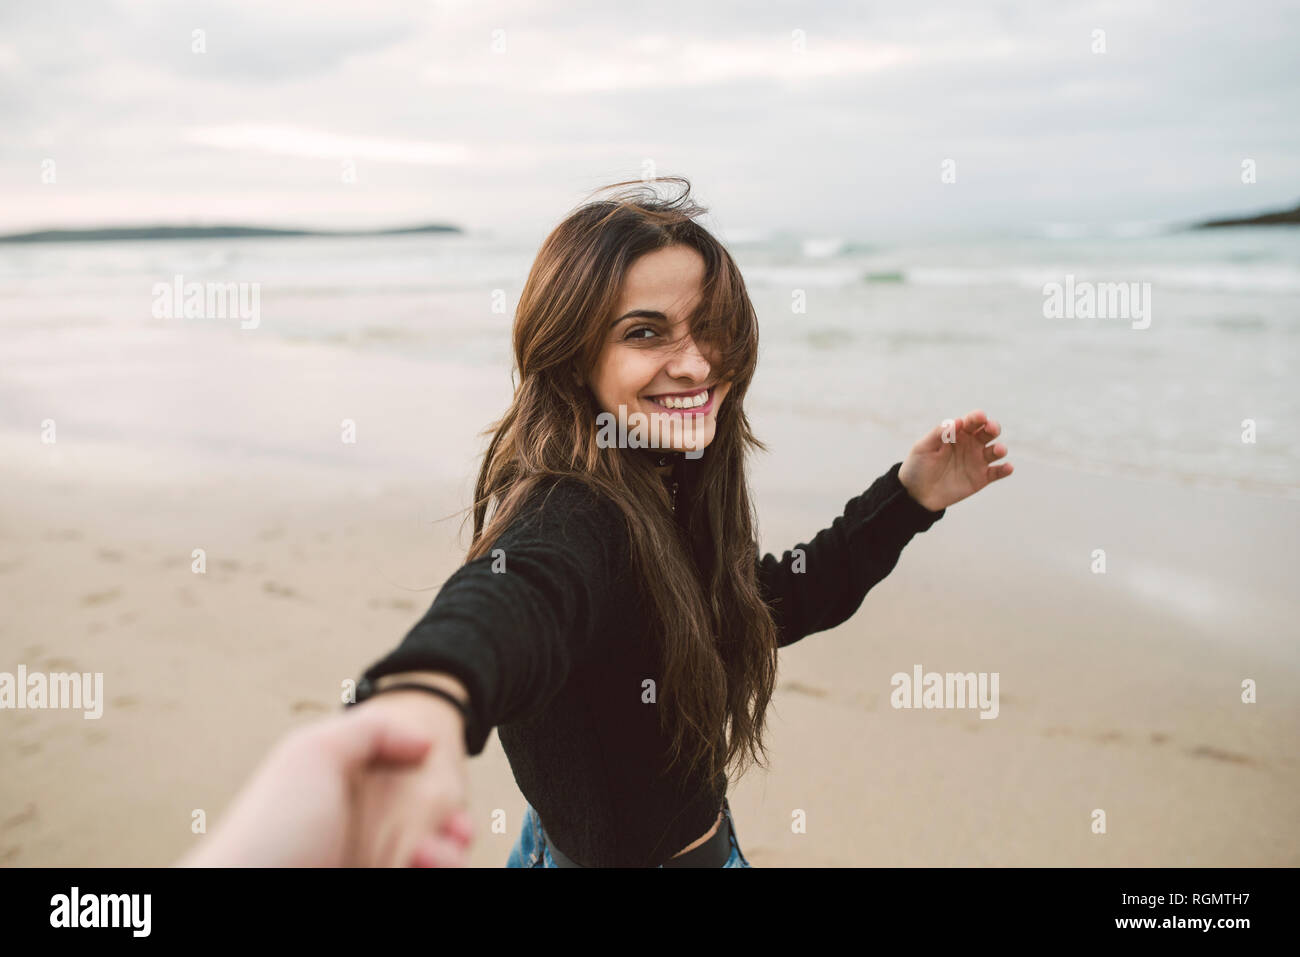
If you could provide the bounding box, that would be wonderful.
[0,419,1300,867]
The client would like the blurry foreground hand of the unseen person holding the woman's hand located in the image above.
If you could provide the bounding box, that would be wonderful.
[178,706,468,867]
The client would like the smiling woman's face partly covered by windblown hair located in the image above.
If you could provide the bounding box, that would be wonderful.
[588,244,731,451]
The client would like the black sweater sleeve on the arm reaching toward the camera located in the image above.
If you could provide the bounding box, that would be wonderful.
[365,479,627,755]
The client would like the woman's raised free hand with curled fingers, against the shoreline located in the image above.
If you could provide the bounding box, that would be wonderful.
[898,408,1011,512]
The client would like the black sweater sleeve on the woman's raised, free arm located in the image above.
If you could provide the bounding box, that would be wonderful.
[758,462,946,648]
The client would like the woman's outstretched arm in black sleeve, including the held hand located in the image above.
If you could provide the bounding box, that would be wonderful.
[354,480,627,866]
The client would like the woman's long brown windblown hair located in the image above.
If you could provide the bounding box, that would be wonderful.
[465,177,776,790]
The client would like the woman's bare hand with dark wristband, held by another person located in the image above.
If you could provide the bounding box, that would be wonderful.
[351,690,473,867]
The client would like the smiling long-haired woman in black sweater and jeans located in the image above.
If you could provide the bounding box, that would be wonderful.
[343,178,1011,867]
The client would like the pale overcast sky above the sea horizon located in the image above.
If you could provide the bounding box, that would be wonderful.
[0,0,1300,239]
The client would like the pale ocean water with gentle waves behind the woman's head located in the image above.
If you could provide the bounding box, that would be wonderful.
[0,228,1300,497]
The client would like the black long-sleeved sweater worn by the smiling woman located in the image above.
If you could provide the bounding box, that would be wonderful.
[365,463,944,867]
